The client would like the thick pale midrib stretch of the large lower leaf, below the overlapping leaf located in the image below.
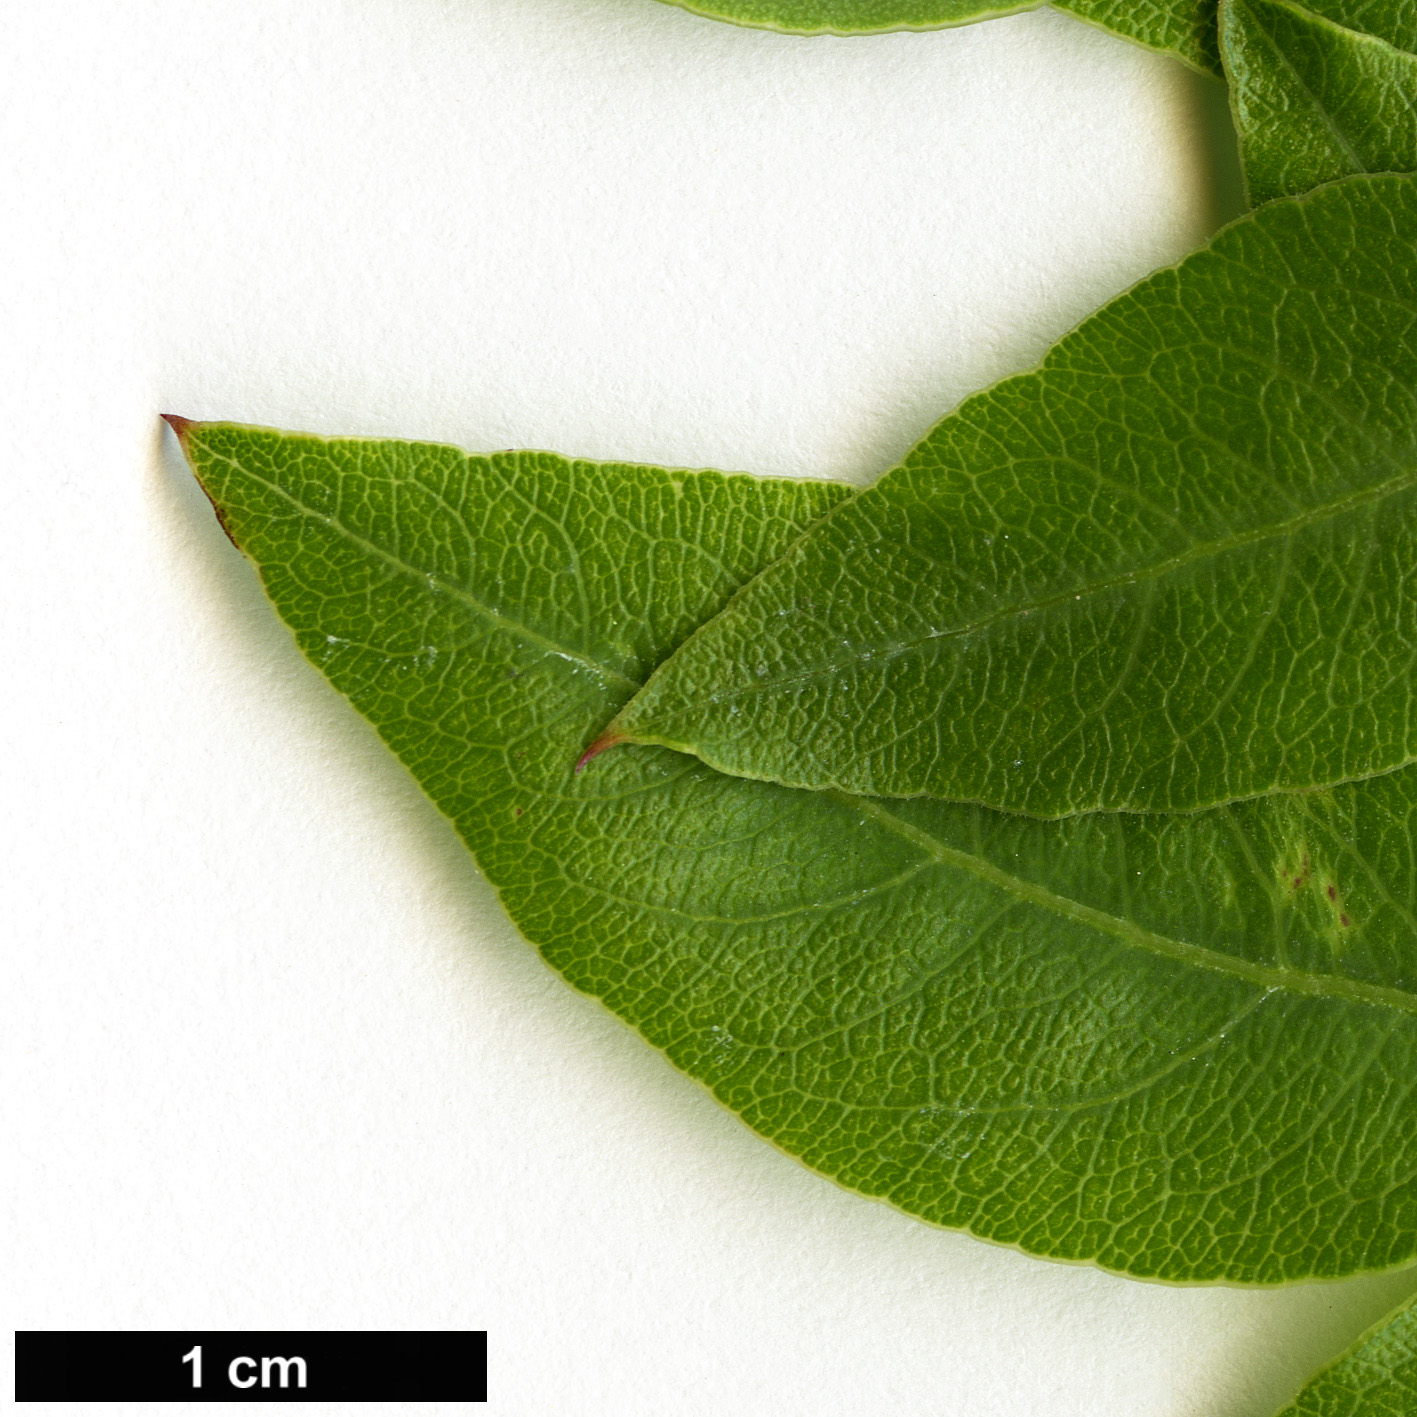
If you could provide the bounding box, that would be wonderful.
[826,788,1417,1015]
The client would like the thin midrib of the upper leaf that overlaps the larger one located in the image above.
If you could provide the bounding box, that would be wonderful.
[663,453,1417,708]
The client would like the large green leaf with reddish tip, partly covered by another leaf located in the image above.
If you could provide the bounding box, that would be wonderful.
[168,421,1417,1282]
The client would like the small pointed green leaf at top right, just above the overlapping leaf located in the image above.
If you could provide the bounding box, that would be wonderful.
[1220,0,1417,204]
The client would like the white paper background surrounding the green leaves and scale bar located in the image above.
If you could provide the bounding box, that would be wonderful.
[8,0,1411,1417]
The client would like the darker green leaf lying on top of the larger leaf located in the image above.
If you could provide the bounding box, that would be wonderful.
[605,177,1417,816]
